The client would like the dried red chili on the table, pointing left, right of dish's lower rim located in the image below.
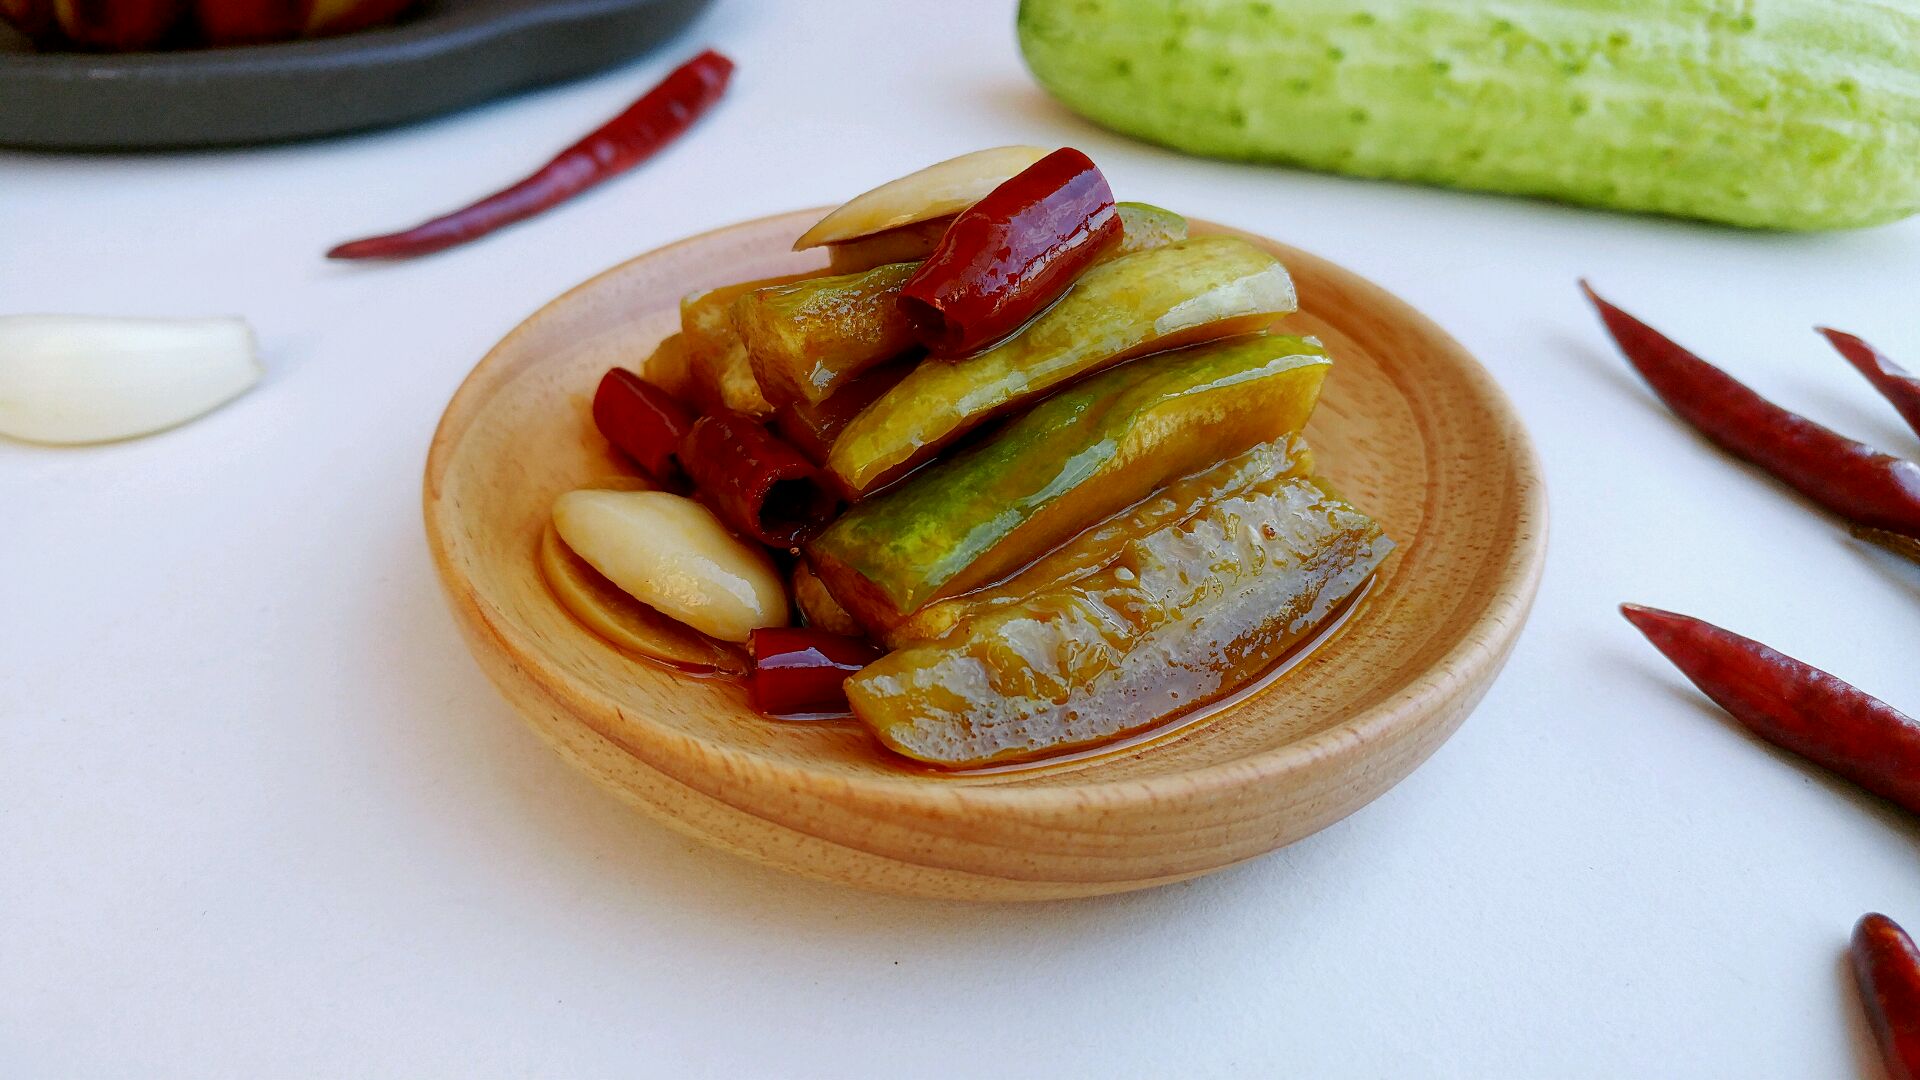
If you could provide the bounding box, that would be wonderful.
[1620,603,1920,813]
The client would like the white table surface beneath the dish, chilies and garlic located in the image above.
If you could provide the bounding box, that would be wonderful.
[0,0,1920,1078]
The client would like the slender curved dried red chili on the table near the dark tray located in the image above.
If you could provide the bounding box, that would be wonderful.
[326,48,733,259]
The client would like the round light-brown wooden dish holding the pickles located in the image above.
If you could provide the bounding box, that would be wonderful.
[424,211,1546,899]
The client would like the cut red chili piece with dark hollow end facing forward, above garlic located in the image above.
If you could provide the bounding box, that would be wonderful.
[680,413,839,548]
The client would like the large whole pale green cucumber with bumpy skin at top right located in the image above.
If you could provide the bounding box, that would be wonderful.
[1018,0,1920,229]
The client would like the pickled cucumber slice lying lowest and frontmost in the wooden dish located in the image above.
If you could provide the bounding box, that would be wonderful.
[847,477,1392,769]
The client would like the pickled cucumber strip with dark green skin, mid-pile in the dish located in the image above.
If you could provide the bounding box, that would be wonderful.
[806,334,1331,632]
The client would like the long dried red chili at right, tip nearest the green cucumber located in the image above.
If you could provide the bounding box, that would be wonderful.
[1580,281,1920,536]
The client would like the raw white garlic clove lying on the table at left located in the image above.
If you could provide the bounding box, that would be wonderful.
[0,315,261,444]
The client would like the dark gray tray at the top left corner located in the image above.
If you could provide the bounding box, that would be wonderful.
[0,0,712,150]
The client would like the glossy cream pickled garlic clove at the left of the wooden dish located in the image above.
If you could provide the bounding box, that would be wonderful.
[553,490,787,642]
